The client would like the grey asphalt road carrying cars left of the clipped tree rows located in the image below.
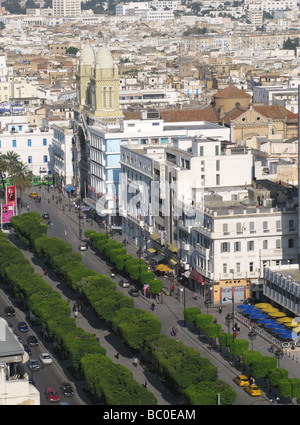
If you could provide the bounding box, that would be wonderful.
[0,285,84,405]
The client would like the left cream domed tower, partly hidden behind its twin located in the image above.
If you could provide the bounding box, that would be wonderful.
[76,44,96,108]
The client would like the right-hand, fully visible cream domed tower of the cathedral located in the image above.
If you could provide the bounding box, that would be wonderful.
[91,46,122,119]
